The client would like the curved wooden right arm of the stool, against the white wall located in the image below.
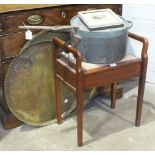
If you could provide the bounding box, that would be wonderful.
[128,32,149,60]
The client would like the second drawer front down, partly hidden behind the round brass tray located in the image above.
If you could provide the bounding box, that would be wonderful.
[1,32,26,59]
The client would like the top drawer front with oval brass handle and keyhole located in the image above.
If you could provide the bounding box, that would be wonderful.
[3,4,120,32]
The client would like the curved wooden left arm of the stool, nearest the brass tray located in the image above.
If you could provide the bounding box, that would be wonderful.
[53,37,82,73]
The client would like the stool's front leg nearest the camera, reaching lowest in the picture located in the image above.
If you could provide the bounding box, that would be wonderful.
[76,89,84,146]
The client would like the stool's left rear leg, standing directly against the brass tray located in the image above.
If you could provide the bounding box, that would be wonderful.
[55,76,62,124]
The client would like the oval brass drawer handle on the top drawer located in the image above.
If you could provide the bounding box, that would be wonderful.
[27,15,43,25]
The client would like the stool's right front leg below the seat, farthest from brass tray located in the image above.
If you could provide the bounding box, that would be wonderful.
[135,76,145,126]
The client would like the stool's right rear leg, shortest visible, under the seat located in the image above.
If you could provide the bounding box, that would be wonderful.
[111,83,116,109]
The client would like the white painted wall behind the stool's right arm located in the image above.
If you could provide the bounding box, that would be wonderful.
[123,4,155,84]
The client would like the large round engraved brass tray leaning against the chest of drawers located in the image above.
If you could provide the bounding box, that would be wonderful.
[4,31,94,126]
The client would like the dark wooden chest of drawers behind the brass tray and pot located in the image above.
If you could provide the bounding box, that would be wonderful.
[0,4,122,129]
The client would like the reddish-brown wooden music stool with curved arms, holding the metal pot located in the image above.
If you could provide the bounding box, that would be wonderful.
[53,33,148,146]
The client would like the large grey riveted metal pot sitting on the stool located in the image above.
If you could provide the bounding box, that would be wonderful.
[70,15,133,64]
